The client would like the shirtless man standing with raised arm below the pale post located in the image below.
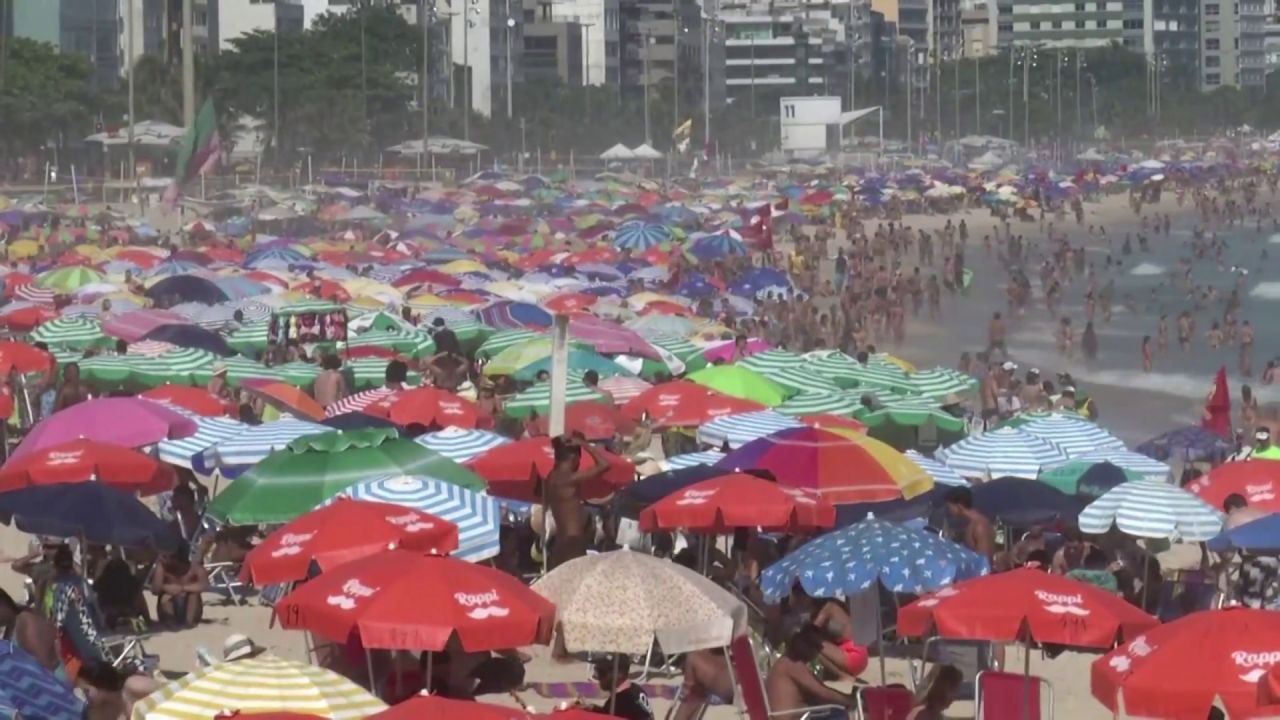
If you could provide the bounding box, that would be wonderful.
[545,436,609,569]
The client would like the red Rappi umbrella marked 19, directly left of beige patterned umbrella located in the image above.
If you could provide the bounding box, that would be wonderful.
[275,550,556,652]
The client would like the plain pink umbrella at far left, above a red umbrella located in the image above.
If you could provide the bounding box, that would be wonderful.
[10,397,196,460]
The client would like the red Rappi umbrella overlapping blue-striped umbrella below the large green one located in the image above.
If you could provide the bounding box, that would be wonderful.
[243,498,458,588]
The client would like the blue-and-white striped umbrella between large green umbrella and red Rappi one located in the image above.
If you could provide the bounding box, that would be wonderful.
[326,475,502,562]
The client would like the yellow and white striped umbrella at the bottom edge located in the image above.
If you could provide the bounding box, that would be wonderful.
[129,655,387,720]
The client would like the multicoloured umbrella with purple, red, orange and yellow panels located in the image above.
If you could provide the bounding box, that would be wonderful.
[717,425,933,503]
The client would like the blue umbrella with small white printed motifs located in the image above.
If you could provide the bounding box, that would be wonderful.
[760,518,991,603]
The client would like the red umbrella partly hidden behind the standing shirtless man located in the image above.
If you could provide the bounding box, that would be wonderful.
[466,437,636,501]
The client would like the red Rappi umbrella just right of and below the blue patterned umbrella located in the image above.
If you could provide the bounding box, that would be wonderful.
[897,568,1160,648]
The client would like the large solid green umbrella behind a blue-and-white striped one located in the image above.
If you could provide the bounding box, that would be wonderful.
[209,428,485,525]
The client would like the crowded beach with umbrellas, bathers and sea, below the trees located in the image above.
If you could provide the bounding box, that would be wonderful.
[0,146,1280,720]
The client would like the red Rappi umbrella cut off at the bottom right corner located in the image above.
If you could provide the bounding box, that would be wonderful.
[1089,607,1280,720]
